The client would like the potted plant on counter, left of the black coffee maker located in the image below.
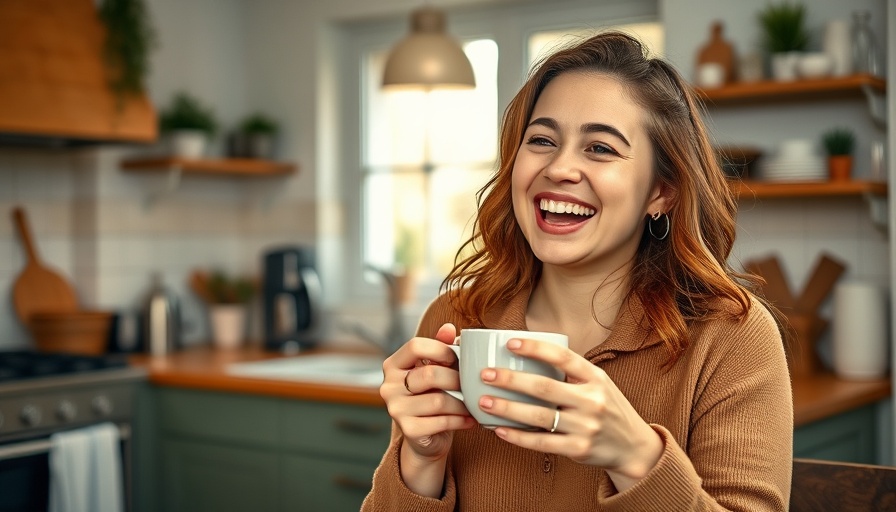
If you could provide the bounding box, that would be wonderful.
[190,270,257,349]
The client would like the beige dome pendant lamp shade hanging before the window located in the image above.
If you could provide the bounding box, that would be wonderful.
[383,6,476,89]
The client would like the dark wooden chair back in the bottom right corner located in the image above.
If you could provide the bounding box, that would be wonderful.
[790,459,896,512]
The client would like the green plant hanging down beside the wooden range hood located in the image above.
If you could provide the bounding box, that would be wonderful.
[99,0,157,101]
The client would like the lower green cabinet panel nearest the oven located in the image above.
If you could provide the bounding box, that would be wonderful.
[159,439,278,512]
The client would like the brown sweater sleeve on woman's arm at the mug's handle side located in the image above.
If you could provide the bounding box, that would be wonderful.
[361,296,457,512]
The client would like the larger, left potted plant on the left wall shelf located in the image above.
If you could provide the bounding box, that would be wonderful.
[159,91,218,158]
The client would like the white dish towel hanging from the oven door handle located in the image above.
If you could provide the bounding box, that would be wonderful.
[49,423,124,512]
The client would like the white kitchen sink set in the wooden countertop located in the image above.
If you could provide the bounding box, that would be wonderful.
[227,354,383,387]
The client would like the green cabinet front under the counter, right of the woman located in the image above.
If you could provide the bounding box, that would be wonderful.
[793,404,878,464]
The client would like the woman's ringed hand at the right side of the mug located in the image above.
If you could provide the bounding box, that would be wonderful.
[479,339,663,491]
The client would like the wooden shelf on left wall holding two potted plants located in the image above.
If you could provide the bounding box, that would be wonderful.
[121,157,296,177]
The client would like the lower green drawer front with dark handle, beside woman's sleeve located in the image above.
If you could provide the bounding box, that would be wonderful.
[281,455,376,512]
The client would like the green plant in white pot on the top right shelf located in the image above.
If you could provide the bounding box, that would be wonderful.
[759,2,809,81]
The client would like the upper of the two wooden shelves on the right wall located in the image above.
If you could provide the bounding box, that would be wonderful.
[696,74,887,105]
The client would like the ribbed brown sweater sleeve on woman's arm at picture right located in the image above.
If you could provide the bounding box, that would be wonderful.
[599,305,793,512]
